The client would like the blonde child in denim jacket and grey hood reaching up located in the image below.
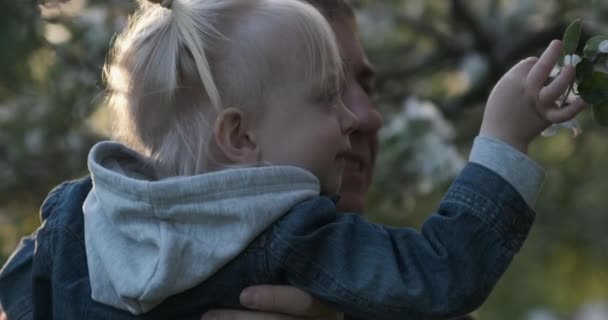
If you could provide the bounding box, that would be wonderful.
[3,0,582,319]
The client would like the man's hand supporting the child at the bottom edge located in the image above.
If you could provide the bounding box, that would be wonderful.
[201,286,344,320]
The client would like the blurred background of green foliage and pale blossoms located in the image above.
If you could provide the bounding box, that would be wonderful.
[0,0,608,320]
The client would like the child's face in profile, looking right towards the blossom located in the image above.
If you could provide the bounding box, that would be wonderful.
[257,76,358,194]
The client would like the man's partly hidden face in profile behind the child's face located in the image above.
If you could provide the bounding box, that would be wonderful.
[330,15,382,212]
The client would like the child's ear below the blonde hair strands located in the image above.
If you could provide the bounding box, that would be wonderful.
[213,108,259,164]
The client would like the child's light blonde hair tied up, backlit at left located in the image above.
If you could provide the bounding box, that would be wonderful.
[104,0,342,177]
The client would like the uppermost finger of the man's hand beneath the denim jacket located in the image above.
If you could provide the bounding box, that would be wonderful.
[240,285,336,318]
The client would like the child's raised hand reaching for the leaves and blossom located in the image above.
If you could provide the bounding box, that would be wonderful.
[480,40,584,153]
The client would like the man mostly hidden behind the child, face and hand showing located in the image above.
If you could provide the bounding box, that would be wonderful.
[202,0,472,320]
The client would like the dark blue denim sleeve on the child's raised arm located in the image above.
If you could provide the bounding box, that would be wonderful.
[267,163,534,319]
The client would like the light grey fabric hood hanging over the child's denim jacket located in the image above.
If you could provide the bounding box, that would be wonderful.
[83,142,320,314]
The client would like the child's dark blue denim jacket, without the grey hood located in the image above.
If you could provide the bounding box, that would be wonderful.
[0,136,534,320]
